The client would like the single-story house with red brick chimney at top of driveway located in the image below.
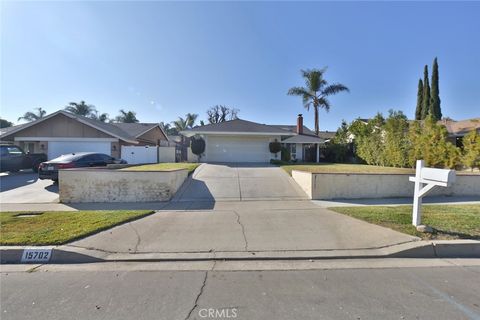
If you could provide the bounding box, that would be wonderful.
[181,114,325,162]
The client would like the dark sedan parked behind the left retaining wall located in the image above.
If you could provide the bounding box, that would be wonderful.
[38,152,127,181]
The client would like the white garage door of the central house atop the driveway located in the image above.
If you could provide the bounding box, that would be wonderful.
[206,136,270,162]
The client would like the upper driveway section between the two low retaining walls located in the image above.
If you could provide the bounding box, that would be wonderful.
[174,163,307,201]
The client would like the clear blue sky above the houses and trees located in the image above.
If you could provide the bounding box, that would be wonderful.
[0,1,480,130]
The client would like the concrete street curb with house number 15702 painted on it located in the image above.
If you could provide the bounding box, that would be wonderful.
[0,240,480,264]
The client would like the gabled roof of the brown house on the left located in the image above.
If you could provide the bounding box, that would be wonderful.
[0,110,167,143]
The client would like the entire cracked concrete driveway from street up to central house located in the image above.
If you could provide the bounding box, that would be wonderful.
[71,164,418,254]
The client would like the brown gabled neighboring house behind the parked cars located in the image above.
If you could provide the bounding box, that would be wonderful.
[0,110,168,159]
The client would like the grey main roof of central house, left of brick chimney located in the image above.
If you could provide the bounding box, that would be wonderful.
[181,119,291,137]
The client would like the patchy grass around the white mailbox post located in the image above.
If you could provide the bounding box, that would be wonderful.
[329,204,480,240]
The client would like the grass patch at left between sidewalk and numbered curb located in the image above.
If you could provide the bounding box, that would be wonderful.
[0,210,153,245]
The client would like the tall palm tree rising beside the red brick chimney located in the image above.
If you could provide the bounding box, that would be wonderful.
[288,68,350,135]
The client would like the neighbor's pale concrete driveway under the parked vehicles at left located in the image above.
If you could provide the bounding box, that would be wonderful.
[0,170,58,204]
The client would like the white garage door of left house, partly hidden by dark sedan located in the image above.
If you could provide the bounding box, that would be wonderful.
[48,141,111,160]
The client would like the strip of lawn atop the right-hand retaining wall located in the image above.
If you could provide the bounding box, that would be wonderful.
[280,162,415,175]
